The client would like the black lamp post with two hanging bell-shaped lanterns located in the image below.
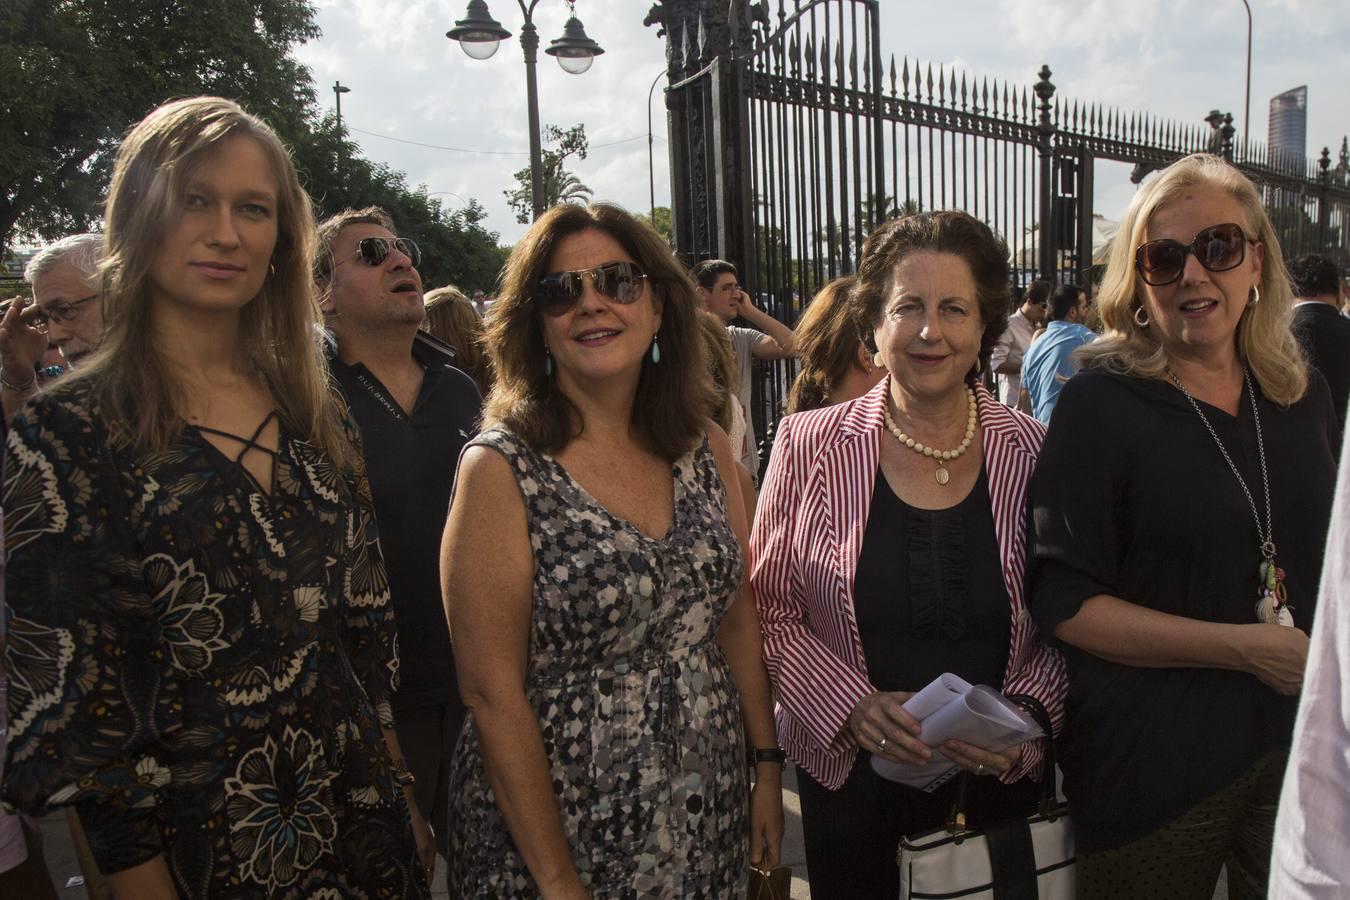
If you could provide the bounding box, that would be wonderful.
[446,0,605,219]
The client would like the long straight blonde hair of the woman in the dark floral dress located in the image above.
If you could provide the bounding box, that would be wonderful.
[74,97,352,466]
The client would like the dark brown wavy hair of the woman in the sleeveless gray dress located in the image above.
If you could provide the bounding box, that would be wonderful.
[483,202,714,463]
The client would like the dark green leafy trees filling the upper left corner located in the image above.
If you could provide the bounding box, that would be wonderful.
[0,0,507,290]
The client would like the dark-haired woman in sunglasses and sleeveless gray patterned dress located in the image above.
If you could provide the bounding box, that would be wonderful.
[441,204,783,899]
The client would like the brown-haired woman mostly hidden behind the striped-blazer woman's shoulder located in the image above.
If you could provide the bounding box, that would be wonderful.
[787,275,886,414]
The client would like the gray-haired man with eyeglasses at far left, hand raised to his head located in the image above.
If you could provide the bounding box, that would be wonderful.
[0,235,103,425]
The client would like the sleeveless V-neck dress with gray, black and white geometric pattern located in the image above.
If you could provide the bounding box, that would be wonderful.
[450,428,749,900]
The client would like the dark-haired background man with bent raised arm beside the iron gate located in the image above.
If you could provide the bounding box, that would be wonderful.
[694,259,797,484]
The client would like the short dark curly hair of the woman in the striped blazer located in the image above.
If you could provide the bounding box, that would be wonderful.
[849,209,1013,385]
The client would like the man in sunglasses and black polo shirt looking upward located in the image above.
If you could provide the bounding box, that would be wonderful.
[316,206,482,879]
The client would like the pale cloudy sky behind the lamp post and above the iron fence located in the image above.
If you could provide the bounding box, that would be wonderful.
[297,0,1350,243]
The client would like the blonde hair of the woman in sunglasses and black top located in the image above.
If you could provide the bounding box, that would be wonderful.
[1077,154,1308,406]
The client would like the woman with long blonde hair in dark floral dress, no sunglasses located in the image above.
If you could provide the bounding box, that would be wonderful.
[4,97,433,900]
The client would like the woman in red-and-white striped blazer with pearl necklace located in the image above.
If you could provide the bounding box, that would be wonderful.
[751,210,1067,900]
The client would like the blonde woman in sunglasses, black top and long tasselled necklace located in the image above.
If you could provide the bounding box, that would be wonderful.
[1030,155,1335,899]
